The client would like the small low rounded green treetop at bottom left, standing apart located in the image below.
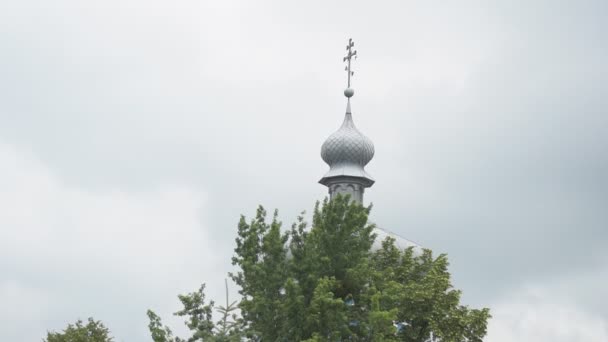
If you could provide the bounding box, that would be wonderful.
[43,318,114,342]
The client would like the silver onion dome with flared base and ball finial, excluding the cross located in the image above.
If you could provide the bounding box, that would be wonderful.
[320,88,374,186]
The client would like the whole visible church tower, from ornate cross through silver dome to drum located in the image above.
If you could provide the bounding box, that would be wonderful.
[319,39,374,204]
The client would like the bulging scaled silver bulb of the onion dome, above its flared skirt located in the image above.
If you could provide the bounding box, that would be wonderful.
[321,101,374,168]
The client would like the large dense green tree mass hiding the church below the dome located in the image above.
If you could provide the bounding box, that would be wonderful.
[231,196,490,342]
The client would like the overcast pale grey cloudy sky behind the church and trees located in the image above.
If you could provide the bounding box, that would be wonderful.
[0,0,608,342]
